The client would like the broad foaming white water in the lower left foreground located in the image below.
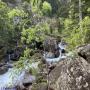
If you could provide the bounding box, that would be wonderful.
[0,62,39,90]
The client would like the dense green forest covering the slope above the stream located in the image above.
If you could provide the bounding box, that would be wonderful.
[0,0,90,86]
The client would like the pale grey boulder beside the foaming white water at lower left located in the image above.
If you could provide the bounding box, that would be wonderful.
[15,71,36,90]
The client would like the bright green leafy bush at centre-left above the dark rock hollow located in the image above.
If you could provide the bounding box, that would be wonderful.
[21,23,49,44]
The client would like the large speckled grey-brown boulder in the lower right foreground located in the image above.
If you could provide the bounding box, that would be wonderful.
[49,57,90,90]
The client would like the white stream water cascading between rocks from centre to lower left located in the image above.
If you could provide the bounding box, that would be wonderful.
[0,42,69,90]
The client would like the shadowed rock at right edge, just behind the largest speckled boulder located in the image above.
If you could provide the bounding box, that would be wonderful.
[78,44,90,63]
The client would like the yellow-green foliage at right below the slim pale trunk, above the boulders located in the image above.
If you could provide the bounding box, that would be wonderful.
[63,16,90,49]
